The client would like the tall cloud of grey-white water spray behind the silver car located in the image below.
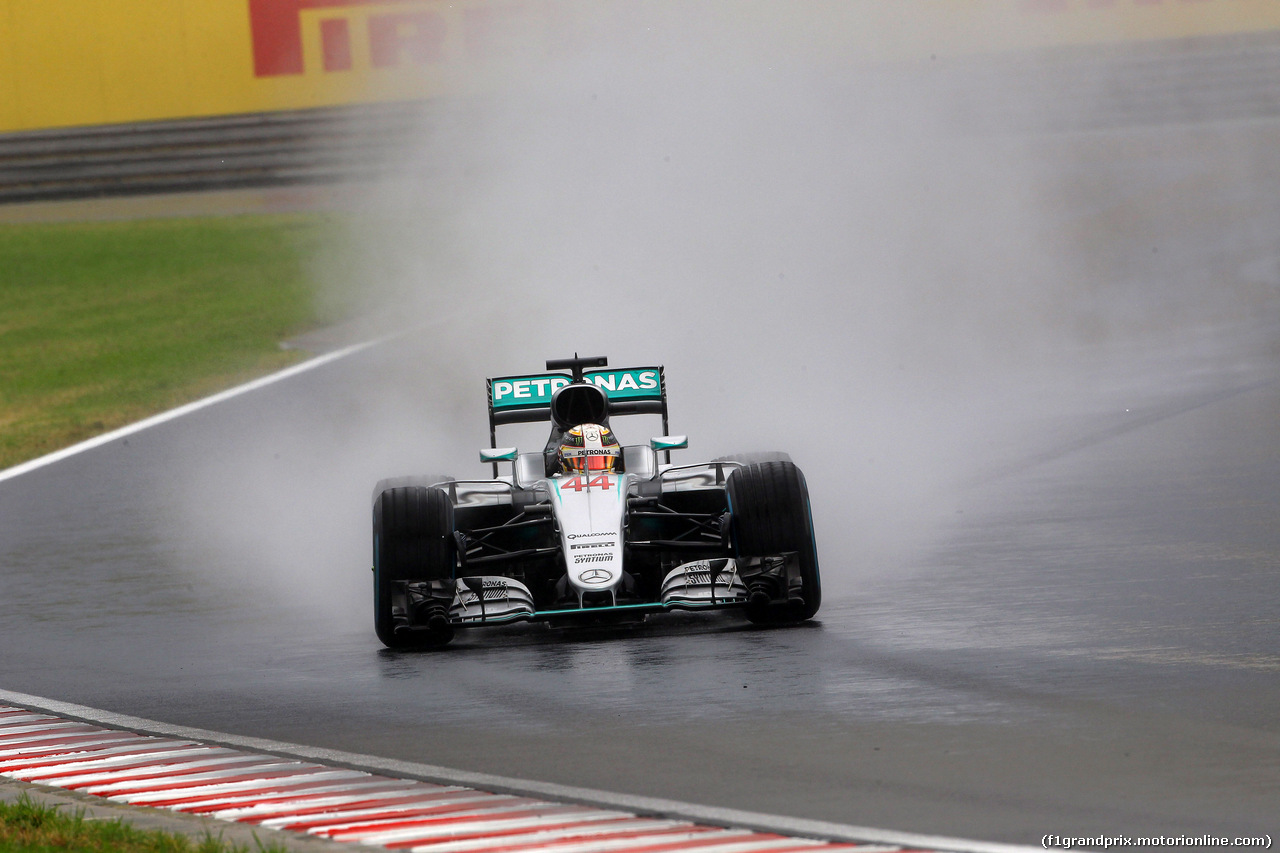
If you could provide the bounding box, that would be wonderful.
[172,3,1280,619]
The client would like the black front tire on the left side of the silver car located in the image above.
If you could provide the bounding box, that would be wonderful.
[374,485,454,648]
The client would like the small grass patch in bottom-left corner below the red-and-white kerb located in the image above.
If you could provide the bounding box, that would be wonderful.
[0,794,287,853]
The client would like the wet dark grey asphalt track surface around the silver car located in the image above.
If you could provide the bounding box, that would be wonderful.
[0,325,1280,844]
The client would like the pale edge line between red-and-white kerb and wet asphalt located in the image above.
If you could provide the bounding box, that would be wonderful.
[0,690,1041,853]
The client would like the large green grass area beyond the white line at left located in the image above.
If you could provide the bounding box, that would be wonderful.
[0,214,348,469]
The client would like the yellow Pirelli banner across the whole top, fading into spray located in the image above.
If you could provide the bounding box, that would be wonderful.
[0,0,1280,132]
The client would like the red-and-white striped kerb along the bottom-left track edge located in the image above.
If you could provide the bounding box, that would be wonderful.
[0,704,931,853]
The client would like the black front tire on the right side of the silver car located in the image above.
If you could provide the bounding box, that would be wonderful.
[726,460,822,624]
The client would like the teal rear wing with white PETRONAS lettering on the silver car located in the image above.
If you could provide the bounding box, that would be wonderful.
[485,359,667,447]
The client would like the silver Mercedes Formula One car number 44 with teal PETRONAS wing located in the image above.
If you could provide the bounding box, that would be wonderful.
[374,357,822,648]
